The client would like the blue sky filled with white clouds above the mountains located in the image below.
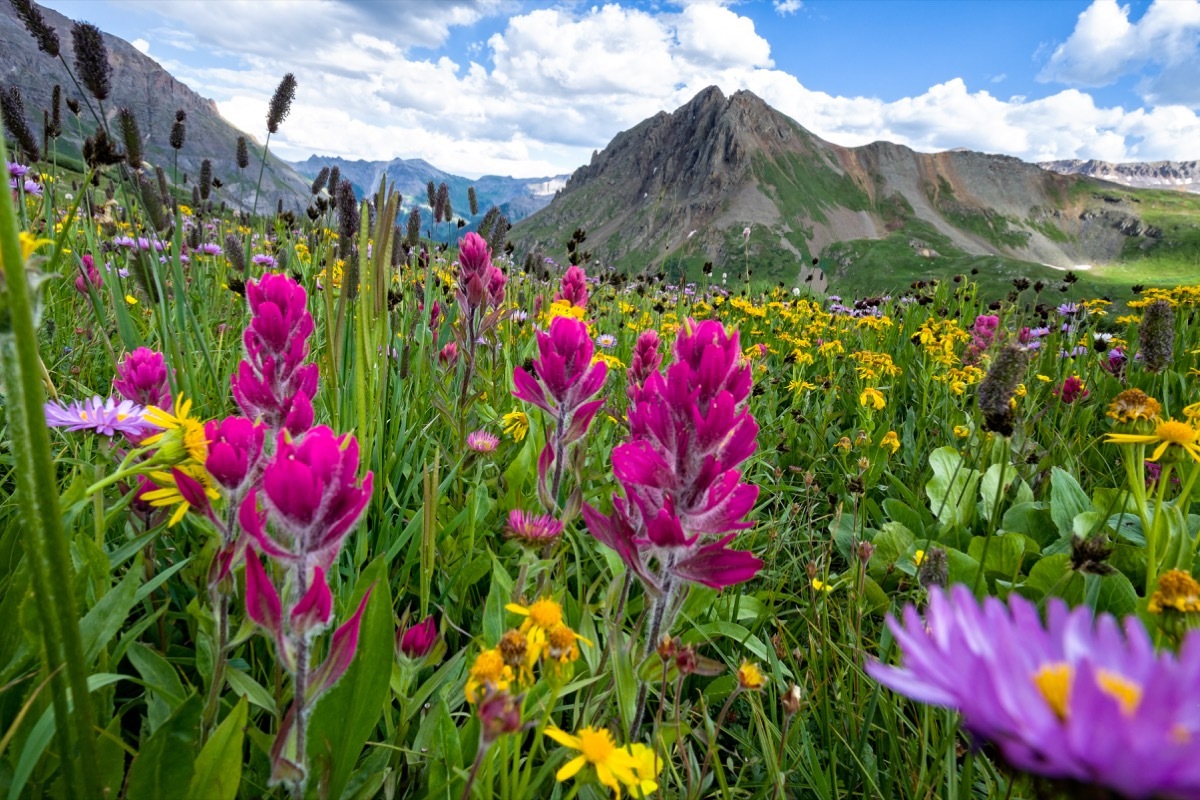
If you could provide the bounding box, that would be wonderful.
[35,0,1200,178]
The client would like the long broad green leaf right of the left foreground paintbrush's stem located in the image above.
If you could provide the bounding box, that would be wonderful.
[308,558,396,798]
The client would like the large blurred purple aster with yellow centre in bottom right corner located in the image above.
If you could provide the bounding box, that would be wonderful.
[866,585,1200,798]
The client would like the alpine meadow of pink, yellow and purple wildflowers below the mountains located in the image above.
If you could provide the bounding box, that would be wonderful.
[0,23,1200,800]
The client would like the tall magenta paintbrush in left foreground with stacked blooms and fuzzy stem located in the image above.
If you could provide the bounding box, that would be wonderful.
[223,275,373,786]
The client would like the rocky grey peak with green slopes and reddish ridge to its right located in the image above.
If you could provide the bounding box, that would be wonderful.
[510,86,1190,279]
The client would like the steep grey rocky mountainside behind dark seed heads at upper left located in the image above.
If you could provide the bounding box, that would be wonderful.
[0,2,308,211]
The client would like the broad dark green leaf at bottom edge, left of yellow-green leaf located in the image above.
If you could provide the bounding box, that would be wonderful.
[125,692,204,800]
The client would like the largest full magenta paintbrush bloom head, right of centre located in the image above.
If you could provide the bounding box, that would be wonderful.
[583,320,762,596]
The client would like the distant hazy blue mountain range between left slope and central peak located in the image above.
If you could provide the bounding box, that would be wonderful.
[290,156,568,232]
